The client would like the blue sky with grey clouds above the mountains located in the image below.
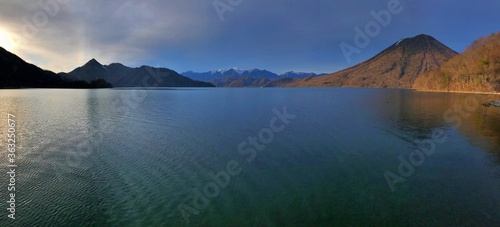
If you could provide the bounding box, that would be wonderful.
[0,0,500,73]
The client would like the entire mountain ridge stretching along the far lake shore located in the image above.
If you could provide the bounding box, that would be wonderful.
[5,33,492,92]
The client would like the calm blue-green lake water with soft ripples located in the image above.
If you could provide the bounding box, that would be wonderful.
[0,88,500,226]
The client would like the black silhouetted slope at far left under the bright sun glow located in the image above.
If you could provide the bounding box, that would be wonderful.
[0,47,111,88]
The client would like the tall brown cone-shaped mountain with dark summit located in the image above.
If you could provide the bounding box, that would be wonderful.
[284,34,457,88]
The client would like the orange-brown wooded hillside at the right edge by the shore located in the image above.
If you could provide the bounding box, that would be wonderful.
[413,32,500,92]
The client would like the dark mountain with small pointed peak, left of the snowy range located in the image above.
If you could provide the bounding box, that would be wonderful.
[60,59,214,87]
